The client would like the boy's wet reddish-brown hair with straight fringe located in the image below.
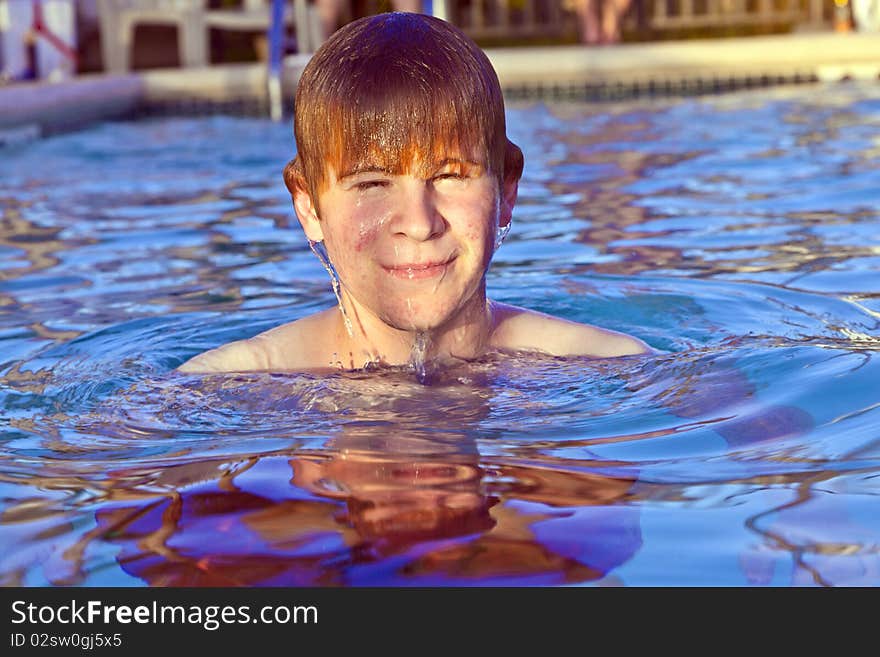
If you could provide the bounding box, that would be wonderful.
[284,12,523,206]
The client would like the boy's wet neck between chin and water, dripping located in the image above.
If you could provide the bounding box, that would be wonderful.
[336,288,494,369]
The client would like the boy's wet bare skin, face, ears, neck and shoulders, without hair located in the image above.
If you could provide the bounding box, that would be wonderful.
[180,156,649,372]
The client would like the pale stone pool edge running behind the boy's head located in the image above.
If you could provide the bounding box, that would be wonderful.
[0,32,880,138]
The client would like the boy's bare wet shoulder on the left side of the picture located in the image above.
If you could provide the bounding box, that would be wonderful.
[177,313,336,374]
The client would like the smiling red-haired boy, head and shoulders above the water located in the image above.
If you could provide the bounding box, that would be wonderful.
[180,13,650,372]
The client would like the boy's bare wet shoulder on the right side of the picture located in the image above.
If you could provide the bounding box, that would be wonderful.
[492,302,652,358]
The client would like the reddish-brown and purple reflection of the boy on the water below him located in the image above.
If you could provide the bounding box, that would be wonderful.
[79,433,641,586]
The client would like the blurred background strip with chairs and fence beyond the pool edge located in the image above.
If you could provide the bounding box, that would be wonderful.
[0,0,880,84]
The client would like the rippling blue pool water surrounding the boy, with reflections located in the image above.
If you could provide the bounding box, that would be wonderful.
[0,83,880,586]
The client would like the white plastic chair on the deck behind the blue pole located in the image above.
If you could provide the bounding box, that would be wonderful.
[97,0,319,73]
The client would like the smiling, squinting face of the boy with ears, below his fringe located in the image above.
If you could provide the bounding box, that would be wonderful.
[294,150,516,331]
